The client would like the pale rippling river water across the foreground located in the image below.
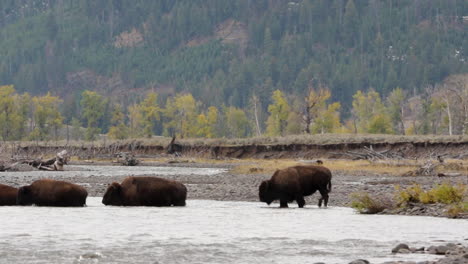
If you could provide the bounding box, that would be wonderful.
[0,197,468,264]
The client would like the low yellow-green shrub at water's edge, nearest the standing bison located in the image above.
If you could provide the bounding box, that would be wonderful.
[351,192,392,214]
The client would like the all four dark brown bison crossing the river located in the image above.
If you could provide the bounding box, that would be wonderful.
[0,165,332,208]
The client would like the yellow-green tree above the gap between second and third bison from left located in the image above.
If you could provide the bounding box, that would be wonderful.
[80,90,105,140]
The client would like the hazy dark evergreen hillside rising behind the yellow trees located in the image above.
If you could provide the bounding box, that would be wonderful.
[0,0,468,140]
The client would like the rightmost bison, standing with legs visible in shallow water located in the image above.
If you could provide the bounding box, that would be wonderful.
[259,165,332,208]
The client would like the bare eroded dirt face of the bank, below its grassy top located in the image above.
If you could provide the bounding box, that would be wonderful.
[5,141,468,159]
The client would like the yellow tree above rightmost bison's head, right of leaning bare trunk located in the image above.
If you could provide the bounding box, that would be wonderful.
[267,90,289,136]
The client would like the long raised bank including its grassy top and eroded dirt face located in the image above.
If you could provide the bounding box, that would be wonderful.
[0,134,468,160]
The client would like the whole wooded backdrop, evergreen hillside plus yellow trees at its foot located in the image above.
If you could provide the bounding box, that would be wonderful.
[0,0,468,140]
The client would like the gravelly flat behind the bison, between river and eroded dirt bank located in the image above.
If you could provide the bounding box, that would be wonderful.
[0,158,468,218]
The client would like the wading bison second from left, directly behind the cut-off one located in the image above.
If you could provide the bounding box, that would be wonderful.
[17,179,88,206]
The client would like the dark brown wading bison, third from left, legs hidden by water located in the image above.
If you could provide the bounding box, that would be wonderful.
[102,176,187,206]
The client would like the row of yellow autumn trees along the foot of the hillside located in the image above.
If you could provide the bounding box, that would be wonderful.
[0,74,468,141]
